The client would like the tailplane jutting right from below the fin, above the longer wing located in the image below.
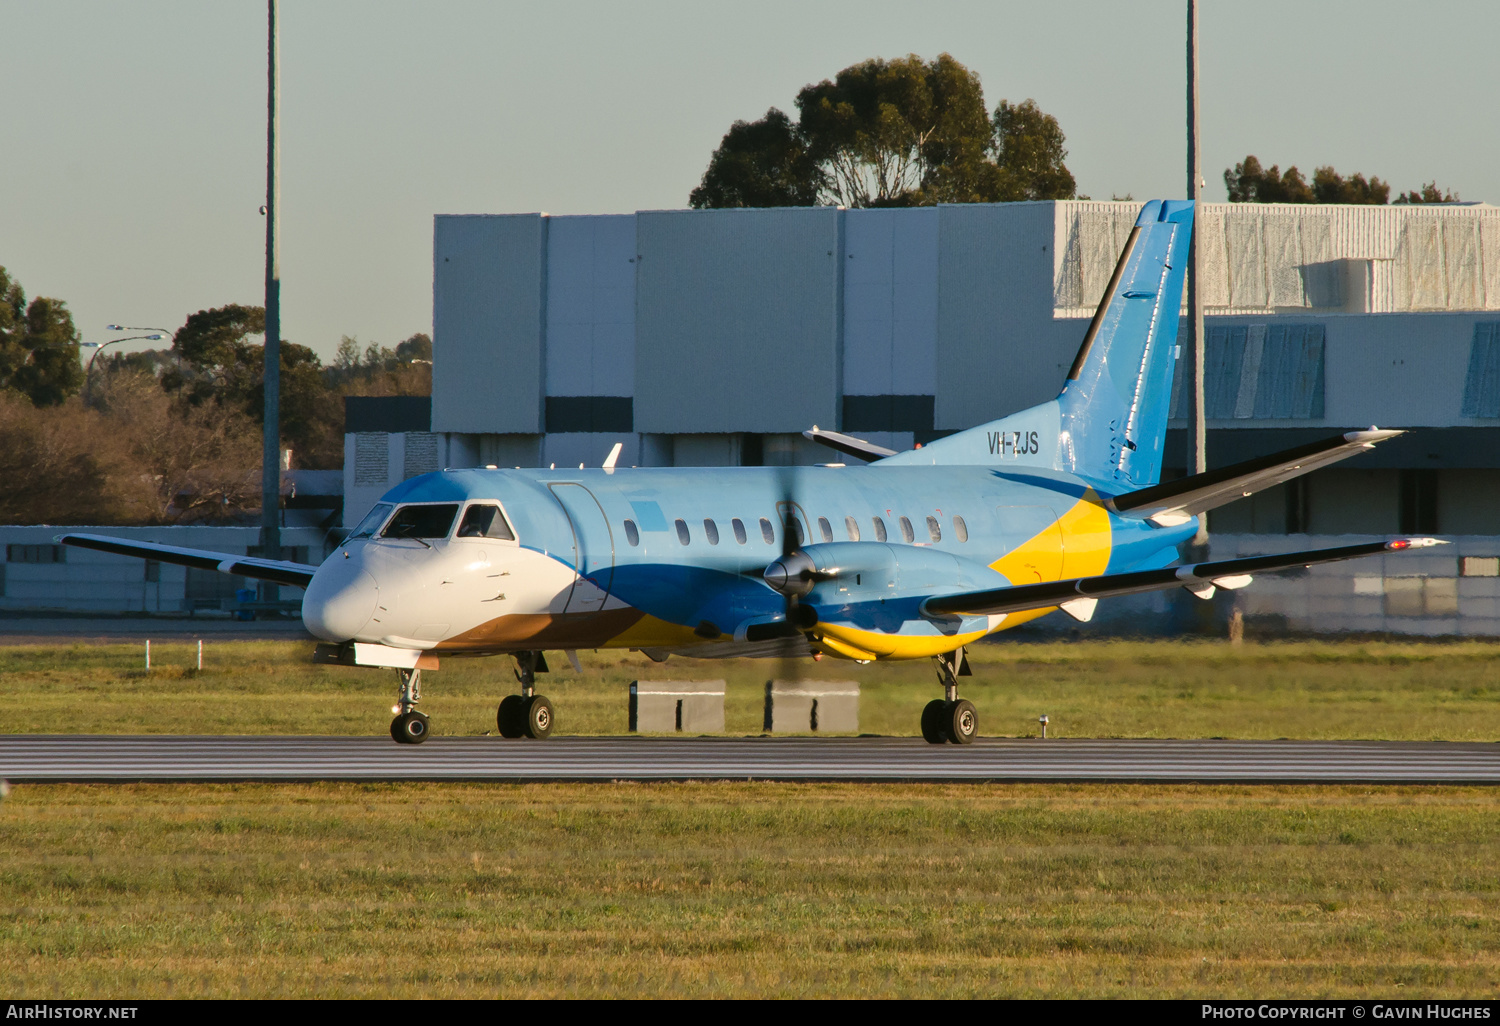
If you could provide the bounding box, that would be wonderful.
[1112,428,1406,527]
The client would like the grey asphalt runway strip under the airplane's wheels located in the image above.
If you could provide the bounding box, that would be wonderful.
[0,734,1500,785]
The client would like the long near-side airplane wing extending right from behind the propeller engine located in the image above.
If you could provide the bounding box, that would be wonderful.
[923,539,1448,617]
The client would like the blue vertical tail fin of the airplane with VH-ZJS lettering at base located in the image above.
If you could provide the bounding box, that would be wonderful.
[882,200,1193,492]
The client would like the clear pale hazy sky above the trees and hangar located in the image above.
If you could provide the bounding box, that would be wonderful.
[0,0,1500,359]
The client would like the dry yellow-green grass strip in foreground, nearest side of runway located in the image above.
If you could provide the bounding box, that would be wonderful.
[0,783,1500,998]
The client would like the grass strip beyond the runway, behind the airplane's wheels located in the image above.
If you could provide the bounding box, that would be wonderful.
[0,641,1500,741]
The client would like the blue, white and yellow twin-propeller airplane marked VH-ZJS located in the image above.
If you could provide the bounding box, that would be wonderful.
[62,201,1439,744]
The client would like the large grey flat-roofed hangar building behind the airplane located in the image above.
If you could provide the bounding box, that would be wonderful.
[344,201,1500,636]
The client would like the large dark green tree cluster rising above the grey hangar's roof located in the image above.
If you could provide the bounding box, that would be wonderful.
[690,54,1076,209]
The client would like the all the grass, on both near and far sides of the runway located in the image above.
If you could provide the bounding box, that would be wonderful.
[0,642,1500,998]
